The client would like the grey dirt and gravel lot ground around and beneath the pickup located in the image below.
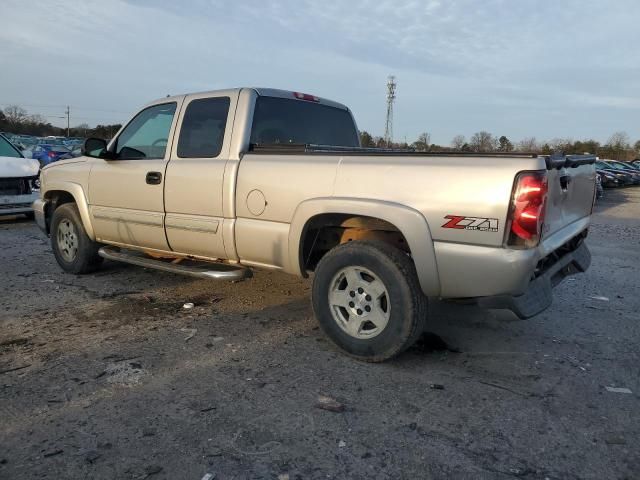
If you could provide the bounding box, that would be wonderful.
[0,189,640,480]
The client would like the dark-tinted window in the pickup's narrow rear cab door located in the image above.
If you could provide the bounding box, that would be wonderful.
[178,97,230,158]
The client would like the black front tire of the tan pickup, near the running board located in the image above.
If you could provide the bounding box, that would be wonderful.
[51,203,103,274]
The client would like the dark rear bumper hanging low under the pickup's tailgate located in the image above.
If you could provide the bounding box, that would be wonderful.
[477,242,591,319]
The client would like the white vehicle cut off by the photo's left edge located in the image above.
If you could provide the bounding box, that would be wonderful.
[0,135,40,218]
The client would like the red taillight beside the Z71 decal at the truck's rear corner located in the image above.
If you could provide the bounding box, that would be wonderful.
[508,172,547,247]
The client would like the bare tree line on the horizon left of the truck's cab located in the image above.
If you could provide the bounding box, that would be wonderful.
[0,105,122,140]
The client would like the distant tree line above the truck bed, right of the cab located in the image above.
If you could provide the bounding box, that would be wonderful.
[360,130,640,160]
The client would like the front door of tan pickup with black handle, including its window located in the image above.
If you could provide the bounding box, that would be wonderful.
[88,101,184,250]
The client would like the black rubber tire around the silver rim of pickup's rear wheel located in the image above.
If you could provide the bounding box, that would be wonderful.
[312,241,427,362]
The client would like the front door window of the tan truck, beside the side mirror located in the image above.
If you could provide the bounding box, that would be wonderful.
[116,103,176,160]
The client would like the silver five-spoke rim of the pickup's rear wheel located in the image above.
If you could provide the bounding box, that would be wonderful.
[328,266,391,339]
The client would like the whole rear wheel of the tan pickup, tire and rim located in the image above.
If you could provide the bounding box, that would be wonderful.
[312,241,427,362]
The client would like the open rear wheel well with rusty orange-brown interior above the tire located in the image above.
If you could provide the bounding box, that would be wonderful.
[300,213,411,272]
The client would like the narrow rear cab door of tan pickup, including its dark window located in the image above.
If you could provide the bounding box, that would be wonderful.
[165,92,237,258]
